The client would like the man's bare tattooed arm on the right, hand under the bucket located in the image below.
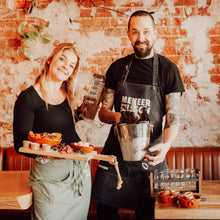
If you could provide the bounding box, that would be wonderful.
[146,93,180,166]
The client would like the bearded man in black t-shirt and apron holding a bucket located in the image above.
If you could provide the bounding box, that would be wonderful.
[92,11,184,220]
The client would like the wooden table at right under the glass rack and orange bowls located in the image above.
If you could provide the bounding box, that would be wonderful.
[155,180,220,219]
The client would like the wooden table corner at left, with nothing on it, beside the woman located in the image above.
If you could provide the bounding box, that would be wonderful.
[0,171,32,210]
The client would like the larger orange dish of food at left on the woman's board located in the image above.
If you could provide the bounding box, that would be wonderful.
[28,131,62,146]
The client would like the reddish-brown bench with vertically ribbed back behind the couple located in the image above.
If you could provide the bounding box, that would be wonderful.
[0,146,220,220]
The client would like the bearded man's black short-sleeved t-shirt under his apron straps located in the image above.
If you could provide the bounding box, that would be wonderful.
[105,54,185,95]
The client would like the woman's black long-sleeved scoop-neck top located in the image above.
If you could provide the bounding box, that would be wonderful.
[13,86,80,157]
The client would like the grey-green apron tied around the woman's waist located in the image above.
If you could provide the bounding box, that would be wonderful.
[29,159,91,220]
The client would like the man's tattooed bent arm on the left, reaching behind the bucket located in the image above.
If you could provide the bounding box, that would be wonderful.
[99,88,121,124]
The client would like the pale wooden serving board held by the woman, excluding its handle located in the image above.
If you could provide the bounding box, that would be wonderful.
[19,147,97,161]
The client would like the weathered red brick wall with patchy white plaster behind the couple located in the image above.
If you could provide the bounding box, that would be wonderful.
[0,0,220,147]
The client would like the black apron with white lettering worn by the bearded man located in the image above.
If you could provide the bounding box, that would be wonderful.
[92,54,167,211]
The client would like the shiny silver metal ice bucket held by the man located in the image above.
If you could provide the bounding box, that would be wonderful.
[116,122,153,161]
